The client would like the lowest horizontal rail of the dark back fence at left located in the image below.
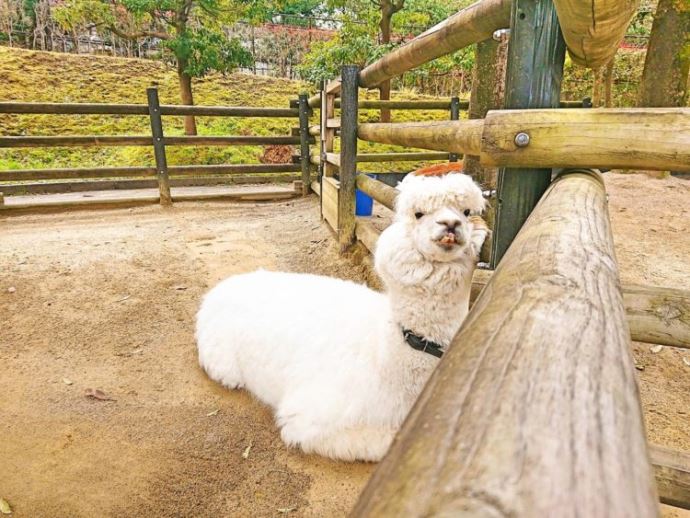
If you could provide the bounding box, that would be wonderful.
[0,164,301,182]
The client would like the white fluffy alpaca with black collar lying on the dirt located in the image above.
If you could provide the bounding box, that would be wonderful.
[196,174,488,461]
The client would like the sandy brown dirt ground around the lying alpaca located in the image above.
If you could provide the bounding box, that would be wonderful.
[0,175,690,517]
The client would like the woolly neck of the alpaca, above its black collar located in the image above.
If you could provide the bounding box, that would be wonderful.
[388,263,472,348]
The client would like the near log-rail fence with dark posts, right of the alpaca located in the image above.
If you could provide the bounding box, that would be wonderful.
[309,0,690,516]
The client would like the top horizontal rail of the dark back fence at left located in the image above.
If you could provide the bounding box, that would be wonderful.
[0,102,299,118]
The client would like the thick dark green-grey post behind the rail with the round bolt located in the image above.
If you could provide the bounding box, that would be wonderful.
[491,0,565,268]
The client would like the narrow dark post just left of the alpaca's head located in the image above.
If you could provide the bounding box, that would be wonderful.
[338,65,359,252]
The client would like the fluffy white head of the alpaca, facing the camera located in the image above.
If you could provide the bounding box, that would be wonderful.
[395,173,486,262]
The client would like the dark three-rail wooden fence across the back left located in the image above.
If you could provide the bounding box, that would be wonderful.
[0,88,314,206]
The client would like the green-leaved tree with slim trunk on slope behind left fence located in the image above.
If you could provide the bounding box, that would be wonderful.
[56,0,252,135]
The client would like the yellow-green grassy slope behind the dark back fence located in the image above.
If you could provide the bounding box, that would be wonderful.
[0,47,447,171]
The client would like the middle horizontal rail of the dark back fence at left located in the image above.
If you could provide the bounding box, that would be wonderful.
[0,135,304,148]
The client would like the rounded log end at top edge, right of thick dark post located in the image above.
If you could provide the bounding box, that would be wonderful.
[554,0,640,68]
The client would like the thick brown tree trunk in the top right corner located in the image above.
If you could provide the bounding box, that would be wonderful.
[639,0,690,107]
